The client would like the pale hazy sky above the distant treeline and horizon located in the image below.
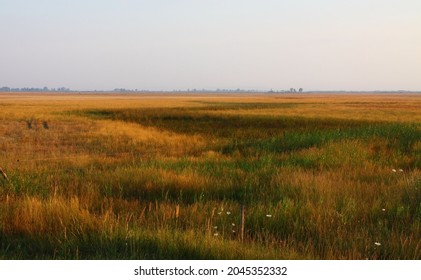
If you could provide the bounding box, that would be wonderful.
[0,0,421,90]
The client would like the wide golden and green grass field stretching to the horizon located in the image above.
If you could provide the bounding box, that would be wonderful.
[0,94,421,259]
